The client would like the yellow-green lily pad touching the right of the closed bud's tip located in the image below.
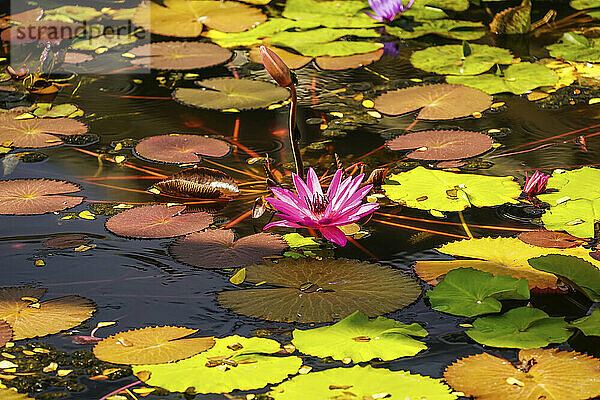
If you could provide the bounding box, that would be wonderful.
[270,28,383,57]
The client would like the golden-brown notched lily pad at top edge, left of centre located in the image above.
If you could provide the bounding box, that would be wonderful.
[133,0,267,37]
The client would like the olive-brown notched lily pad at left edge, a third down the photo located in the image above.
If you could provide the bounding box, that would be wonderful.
[0,113,88,148]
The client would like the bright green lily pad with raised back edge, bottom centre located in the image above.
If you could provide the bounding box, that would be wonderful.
[292,311,427,363]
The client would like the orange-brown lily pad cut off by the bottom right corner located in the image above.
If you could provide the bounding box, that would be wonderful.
[444,349,600,400]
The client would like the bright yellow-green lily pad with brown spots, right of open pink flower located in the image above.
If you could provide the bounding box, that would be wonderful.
[382,167,521,211]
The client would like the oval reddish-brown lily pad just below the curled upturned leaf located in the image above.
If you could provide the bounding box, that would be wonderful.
[106,204,213,239]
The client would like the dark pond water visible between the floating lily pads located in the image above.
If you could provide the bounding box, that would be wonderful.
[0,1,600,399]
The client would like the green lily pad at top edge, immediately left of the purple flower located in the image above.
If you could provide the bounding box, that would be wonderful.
[282,0,380,28]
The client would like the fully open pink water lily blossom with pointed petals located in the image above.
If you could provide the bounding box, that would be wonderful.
[264,168,379,246]
